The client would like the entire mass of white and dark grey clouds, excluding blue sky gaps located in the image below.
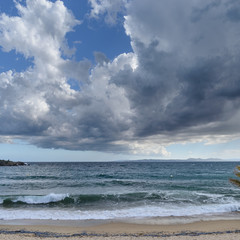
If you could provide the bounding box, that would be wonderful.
[0,0,240,154]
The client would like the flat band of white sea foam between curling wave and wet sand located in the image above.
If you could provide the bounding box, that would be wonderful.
[0,203,240,220]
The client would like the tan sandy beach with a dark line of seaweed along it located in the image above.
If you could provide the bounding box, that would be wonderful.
[0,220,240,240]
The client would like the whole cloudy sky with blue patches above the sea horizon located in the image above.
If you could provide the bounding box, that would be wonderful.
[0,0,240,161]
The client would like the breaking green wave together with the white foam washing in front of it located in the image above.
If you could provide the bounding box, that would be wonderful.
[0,191,240,220]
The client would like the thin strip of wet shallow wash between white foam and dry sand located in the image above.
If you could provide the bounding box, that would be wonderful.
[0,211,240,227]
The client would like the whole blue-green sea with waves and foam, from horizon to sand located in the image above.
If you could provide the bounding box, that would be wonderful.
[0,161,240,223]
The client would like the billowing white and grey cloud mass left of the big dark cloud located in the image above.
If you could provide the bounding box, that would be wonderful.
[0,0,134,151]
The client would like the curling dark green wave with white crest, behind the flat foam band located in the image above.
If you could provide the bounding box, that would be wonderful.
[0,191,238,208]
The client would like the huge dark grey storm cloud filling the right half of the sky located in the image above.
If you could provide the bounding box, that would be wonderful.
[113,1,240,139]
